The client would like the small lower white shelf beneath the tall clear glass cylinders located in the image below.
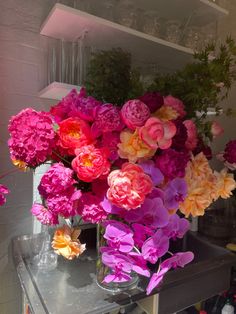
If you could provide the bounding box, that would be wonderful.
[38,82,80,100]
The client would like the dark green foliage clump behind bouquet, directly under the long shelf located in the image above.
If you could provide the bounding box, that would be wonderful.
[85,48,142,105]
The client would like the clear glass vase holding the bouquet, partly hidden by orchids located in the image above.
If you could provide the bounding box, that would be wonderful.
[96,224,139,294]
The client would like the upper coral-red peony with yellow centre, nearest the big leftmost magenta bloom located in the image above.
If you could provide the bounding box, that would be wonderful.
[58,118,93,155]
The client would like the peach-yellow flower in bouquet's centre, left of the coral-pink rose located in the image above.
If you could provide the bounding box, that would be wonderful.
[117,129,155,162]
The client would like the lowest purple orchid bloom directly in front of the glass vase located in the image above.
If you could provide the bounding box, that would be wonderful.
[102,250,133,283]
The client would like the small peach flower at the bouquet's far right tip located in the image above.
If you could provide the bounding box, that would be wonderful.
[214,169,236,198]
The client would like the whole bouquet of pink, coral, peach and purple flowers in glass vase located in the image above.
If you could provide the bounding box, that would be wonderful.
[8,88,236,294]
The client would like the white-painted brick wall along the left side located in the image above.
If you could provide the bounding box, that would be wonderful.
[0,0,60,314]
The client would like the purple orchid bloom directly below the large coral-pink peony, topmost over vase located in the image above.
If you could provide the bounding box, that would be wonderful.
[104,220,134,253]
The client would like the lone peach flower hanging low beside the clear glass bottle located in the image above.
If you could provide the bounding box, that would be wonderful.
[52,225,85,260]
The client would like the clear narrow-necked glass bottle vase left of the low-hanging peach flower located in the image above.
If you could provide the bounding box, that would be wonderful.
[33,225,58,271]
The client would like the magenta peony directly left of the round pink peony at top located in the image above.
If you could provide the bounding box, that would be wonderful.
[91,104,123,137]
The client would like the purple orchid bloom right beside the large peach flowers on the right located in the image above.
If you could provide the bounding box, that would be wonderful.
[164,178,187,209]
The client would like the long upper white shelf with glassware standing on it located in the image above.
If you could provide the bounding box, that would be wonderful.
[40,3,193,69]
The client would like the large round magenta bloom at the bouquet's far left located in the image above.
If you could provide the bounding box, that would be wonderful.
[8,108,55,167]
